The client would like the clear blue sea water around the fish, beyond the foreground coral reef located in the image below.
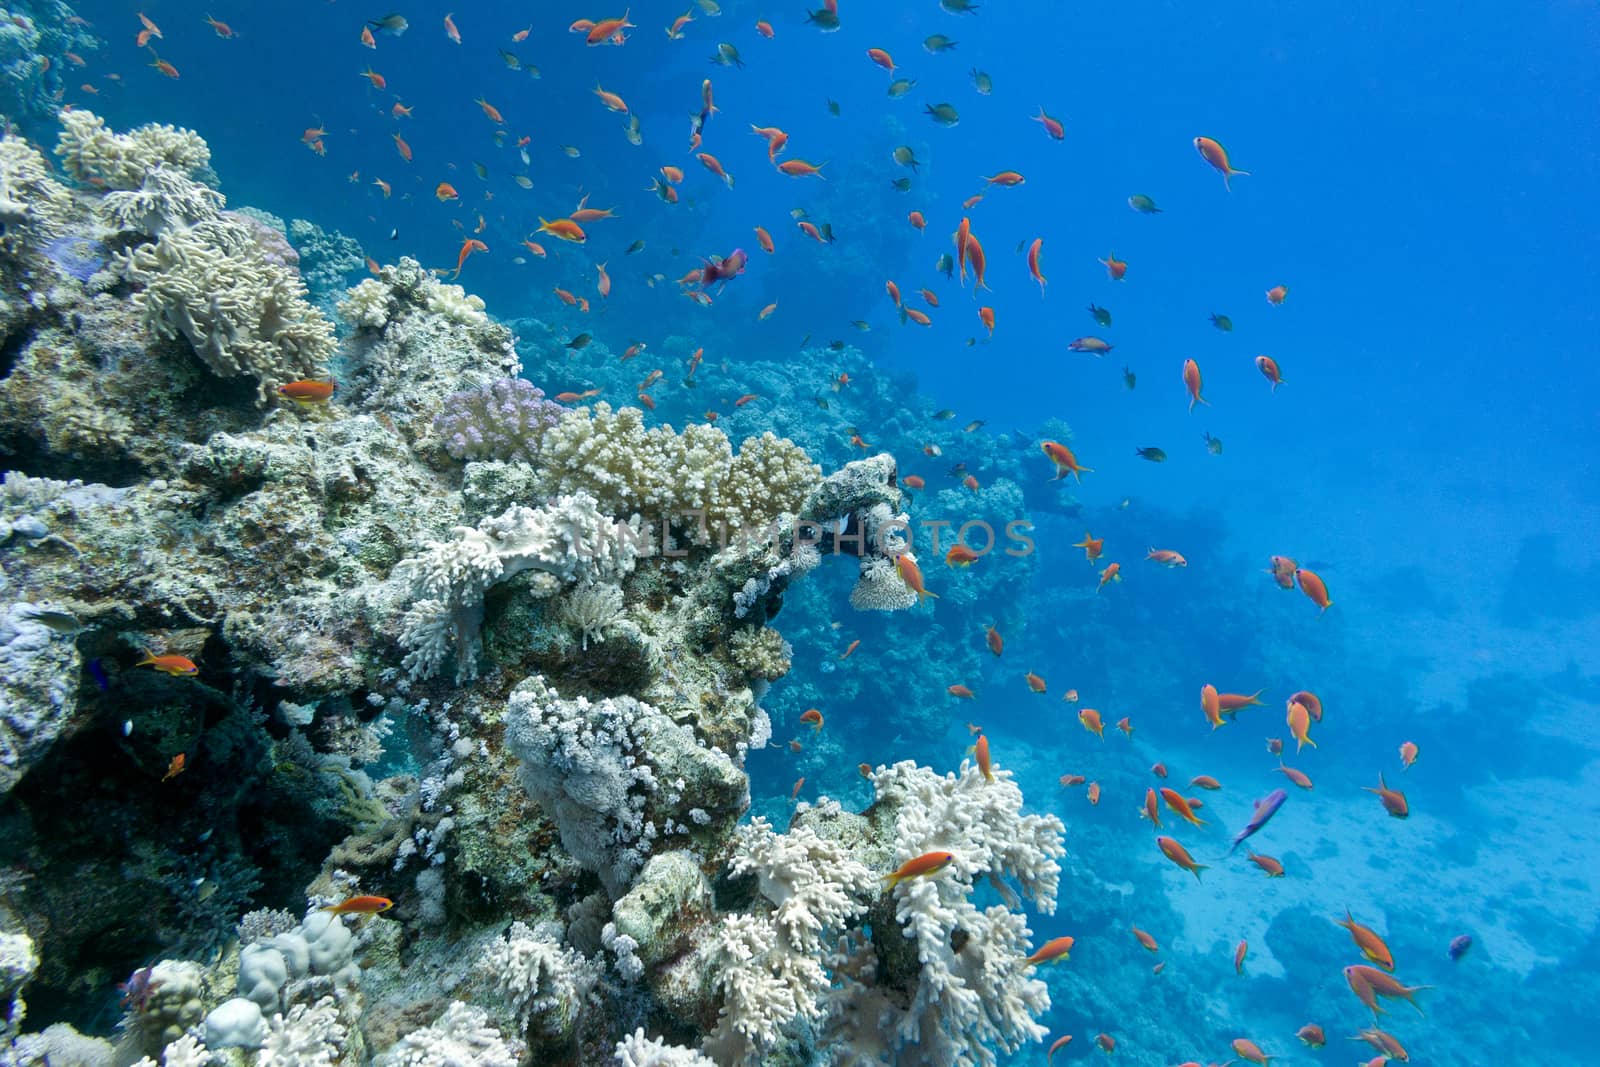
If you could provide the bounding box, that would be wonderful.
[53,0,1600,1064]
